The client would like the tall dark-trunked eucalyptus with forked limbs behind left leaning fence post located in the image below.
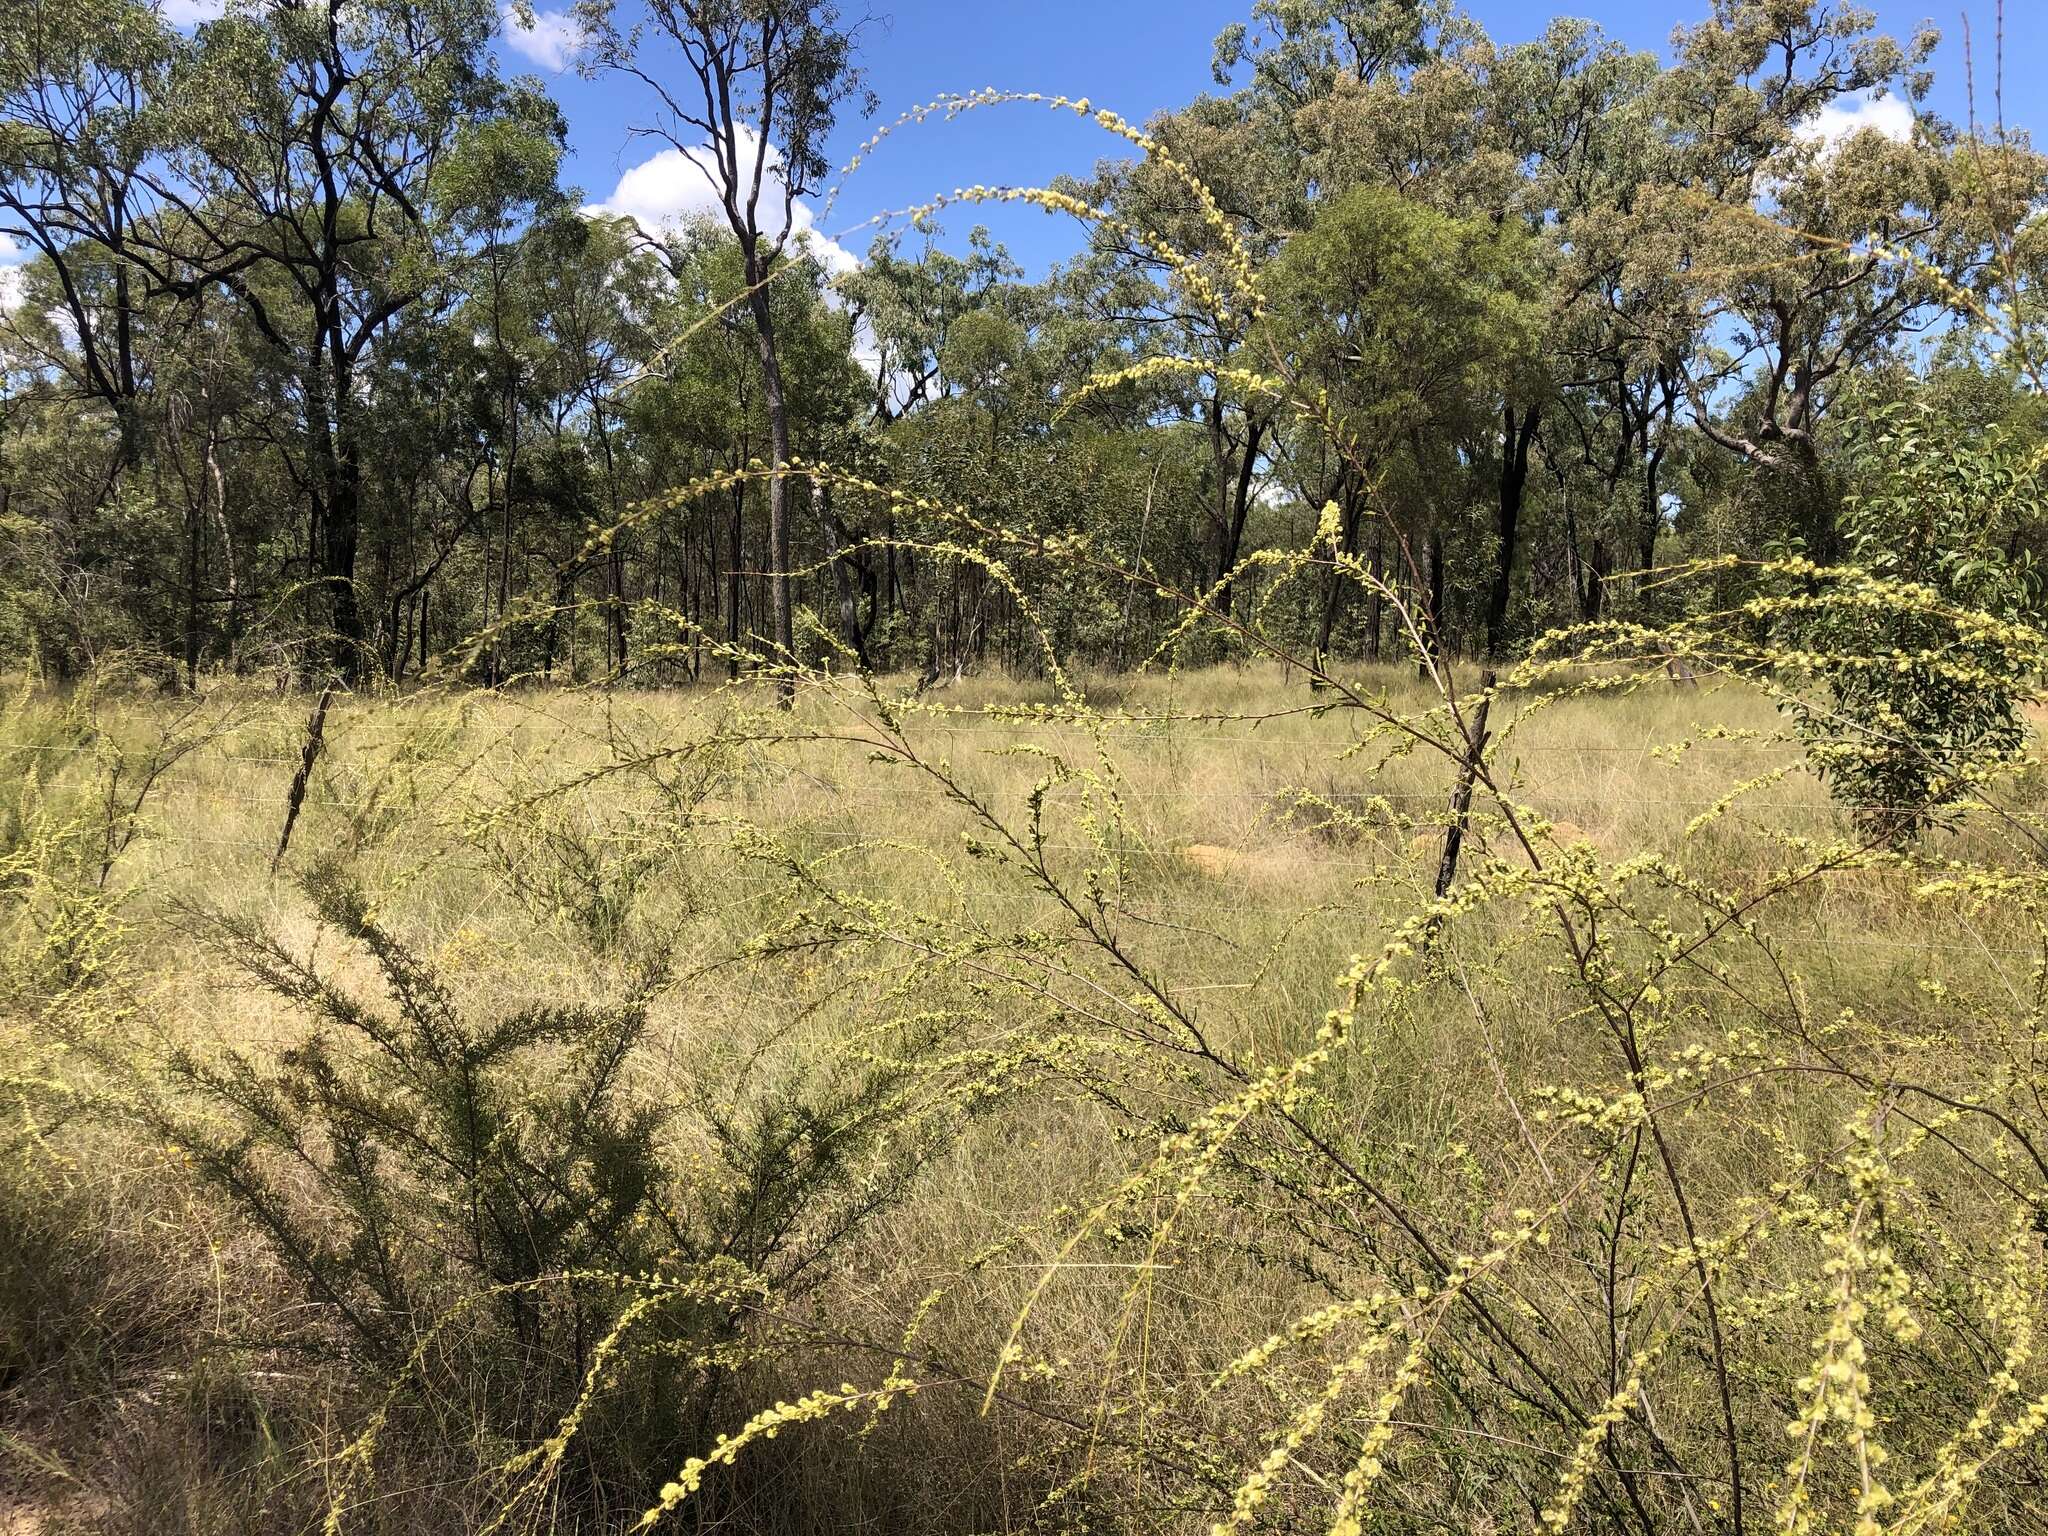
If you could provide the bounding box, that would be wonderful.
[141,0,561,674]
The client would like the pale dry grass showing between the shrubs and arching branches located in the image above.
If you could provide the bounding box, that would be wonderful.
[0,668,2032,1536]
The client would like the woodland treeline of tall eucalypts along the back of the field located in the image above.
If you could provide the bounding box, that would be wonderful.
[0,0,2048,684]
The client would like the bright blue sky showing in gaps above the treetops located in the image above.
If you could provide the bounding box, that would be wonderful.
[499,0,2048,272]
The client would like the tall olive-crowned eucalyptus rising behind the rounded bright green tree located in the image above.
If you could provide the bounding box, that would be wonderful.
[1266,6,1690,653]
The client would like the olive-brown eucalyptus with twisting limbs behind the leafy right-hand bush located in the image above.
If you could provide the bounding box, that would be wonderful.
[1626,0,1949,559]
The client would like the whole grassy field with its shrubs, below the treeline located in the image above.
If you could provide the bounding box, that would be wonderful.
[0,634,2048,1532]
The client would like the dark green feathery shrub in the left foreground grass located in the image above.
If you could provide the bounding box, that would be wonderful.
[143,866,942,1523]
